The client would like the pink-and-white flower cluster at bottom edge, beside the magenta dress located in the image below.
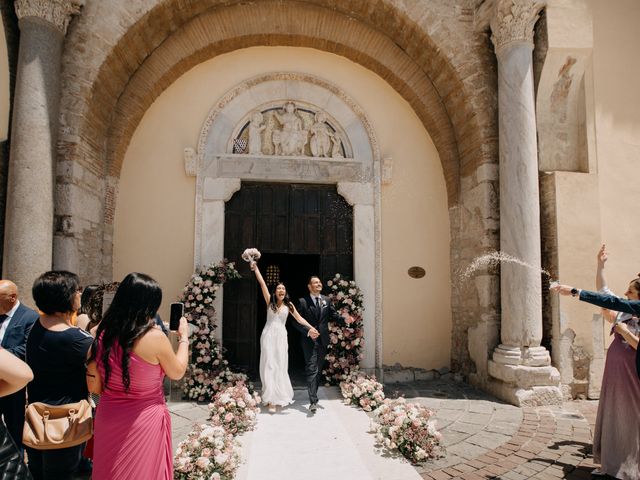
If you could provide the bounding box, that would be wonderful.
[173,424,240,480]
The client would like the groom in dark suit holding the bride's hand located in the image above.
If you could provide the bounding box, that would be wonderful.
[294,275,345,413]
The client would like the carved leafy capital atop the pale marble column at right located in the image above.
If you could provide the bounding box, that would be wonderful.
[490,0,545,55]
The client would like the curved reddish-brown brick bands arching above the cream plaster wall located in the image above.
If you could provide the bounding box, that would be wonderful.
[61,0,495,205]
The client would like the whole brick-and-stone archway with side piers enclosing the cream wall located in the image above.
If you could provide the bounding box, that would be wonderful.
[54,0,498,376]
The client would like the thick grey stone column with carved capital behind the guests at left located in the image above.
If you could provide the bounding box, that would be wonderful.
[3,0,80,304]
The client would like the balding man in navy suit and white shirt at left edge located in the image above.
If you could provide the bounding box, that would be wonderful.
[0,280,38,447]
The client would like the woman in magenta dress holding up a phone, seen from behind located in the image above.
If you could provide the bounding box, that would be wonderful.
[87,273,189,480]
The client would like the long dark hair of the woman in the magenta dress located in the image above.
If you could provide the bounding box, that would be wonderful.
[92,272,162,391]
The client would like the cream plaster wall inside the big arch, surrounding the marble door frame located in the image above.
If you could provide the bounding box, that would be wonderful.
[113,47,451,368]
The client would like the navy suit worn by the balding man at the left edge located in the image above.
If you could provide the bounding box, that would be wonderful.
[0,303,38,446]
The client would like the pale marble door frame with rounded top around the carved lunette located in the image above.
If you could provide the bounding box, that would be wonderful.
[194,72,382,372]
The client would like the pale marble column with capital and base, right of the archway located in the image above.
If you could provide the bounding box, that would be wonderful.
[489,0,561,405]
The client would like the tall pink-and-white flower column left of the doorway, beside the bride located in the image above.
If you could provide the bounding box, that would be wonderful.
[180,260,246,402]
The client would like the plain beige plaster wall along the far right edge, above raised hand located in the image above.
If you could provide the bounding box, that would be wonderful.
[584,0,640,288]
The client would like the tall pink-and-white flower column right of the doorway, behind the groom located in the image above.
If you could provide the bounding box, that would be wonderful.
[322,273,364,385]
